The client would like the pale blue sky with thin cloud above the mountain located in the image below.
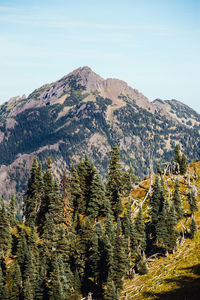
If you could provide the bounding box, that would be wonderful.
[0,0,200,113]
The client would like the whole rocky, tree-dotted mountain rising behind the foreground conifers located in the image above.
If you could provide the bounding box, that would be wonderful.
[0,67,200,199]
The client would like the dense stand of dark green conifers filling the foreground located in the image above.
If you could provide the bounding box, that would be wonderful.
[0,146,198,300]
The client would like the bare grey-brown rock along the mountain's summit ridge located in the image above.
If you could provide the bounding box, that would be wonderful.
[3,66,155,118]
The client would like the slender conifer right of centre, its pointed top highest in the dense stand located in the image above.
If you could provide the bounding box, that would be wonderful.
[106,146,122,220]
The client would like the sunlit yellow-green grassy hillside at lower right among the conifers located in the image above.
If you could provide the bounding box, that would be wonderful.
[122,162,200,299]
